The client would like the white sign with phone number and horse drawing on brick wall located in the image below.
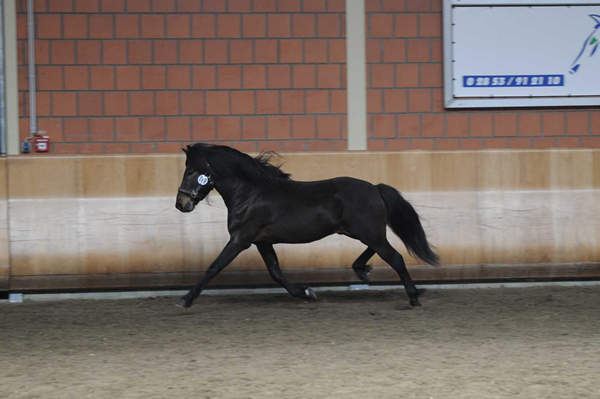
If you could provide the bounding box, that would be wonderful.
[444,0,600,108]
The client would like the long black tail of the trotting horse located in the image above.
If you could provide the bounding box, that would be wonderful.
[376,184,439,265]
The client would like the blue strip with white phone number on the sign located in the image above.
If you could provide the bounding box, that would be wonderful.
[463,75,565,87]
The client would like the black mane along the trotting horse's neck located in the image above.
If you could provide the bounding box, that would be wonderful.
[188,143,290,183]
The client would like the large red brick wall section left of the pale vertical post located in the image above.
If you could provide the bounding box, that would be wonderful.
[18,0,346,153]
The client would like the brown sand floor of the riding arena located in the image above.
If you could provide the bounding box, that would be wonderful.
[0,286,600,399]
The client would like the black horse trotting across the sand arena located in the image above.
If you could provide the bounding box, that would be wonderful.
[175,143,438,308]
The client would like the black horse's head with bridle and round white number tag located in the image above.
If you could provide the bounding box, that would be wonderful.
[175,146,215,212]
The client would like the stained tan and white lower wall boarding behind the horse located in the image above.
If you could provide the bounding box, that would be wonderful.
[0,149,600,290]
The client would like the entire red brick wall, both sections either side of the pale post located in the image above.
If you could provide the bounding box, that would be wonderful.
[18,0,600,153]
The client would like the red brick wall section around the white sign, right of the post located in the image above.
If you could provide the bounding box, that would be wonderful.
[366,0,600,150]
